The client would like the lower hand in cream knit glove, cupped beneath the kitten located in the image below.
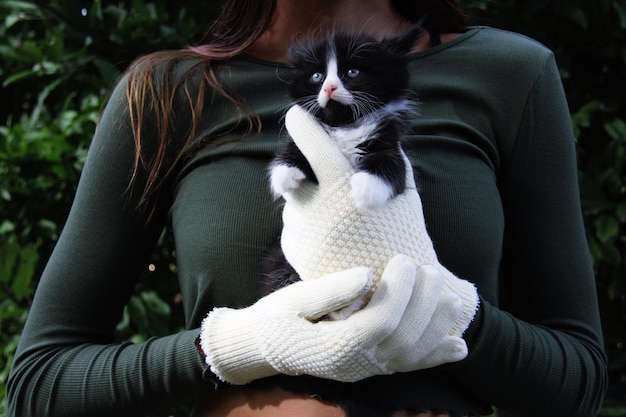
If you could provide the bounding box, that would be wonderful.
[201,255,467,385]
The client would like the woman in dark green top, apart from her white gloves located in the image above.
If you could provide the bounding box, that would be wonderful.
[7,0,606,417]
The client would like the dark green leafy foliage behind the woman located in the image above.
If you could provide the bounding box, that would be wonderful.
[0,0,626,417]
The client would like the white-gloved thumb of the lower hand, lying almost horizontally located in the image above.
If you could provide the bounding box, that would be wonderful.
[263,267,374,320]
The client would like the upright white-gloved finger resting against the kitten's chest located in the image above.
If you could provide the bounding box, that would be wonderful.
[285,105,352,186]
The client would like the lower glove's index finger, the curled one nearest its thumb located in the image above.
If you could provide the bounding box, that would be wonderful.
[336,255,415,344]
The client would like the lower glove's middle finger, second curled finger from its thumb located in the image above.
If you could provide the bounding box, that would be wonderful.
[372,265,444,361]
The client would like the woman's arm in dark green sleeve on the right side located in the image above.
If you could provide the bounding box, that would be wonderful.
[450,50,607,416]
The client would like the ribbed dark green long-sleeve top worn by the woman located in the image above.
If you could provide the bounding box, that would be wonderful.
[7,27,606,417]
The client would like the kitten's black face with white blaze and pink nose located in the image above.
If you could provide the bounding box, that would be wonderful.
[289,34,408,126]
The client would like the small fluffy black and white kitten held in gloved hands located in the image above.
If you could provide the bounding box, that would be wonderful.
[270,26,420,209]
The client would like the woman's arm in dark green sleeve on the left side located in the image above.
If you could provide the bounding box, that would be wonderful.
[7,74,203,417]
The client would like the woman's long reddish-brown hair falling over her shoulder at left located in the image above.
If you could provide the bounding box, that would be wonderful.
[126,0,469,218]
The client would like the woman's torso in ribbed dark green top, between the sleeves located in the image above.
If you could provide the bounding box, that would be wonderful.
[170,28,552,410]
